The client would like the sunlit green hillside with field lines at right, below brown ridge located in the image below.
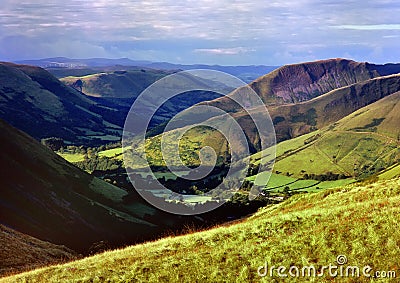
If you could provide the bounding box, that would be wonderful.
[253,92,400,181]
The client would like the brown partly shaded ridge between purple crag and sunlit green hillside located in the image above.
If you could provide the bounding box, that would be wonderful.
[268,75,400,141]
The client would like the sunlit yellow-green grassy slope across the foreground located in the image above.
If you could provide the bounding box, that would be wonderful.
[1,179,400,282]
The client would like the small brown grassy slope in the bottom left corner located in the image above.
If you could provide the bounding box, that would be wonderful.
[0,225,77,276]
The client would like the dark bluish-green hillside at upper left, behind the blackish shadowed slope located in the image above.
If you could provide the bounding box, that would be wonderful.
[0,63,121,143]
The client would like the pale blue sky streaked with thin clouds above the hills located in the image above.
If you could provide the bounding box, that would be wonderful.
[0,0,400,66]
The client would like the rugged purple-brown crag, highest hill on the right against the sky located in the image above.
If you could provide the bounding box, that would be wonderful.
[206,59,400,112]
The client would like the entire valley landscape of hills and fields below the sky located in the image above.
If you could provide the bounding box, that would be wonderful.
[0,58,400,282]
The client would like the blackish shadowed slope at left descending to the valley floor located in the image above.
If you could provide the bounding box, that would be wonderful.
[0,118,166,252]
